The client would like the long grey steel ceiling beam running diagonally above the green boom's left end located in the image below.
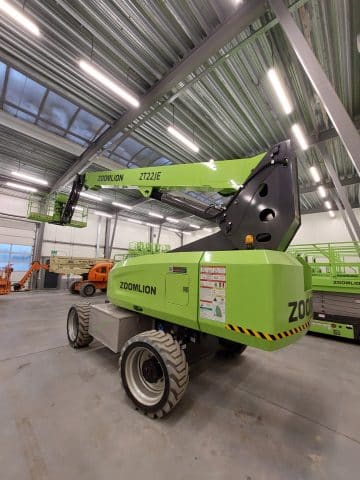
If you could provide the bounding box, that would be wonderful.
[53,0,266,191]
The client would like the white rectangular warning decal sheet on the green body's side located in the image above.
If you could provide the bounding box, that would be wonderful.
[199,265,226,323]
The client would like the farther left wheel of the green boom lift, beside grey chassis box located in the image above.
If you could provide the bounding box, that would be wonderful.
[66,302,93,348]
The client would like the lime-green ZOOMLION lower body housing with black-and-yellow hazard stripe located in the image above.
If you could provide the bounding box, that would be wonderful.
[107,250,311,350]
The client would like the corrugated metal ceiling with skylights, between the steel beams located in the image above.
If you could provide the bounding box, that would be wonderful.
[0,0,360,221]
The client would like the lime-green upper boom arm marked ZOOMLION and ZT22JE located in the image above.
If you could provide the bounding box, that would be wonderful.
[85,153,265,196]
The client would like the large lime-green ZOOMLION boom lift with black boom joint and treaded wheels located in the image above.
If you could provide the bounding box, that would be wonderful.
[62,140,311,417]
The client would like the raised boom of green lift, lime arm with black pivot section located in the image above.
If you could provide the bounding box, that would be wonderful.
[62,140,300,251]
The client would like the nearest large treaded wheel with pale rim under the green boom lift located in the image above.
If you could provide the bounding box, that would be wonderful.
[120,330,189,418]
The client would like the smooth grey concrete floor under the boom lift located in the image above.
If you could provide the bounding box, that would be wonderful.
[0,292,360,480]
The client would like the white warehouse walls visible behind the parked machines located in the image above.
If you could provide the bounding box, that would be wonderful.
[0,191,360,266]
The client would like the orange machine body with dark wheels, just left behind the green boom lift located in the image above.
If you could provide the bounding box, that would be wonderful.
[70,262,114,297]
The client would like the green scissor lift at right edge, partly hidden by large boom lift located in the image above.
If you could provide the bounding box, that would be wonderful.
[288,242,360,342]
